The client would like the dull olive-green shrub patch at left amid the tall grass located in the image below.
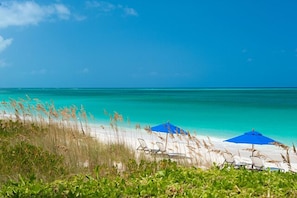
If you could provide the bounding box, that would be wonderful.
[0,141,67,183]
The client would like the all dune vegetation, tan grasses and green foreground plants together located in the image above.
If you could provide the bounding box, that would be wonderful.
[0,97,297,197]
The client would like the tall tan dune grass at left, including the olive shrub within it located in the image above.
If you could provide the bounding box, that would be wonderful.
[0,97,135,180]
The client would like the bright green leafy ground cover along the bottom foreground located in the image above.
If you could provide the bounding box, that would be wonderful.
[0,161,297,197]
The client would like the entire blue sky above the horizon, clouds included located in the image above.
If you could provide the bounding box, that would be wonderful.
[0,0,297,88]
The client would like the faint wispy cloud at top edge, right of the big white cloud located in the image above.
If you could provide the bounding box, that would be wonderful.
[86,1,138,16]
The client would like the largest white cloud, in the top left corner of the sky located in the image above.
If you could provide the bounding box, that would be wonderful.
[0,1,71,28]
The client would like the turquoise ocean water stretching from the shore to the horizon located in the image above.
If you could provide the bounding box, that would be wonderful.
[0,88,297,145]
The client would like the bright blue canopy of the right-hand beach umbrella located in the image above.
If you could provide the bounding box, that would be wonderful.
[225,130,276,144]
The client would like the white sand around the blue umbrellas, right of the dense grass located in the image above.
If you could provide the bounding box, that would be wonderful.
[86,125,297,172]
